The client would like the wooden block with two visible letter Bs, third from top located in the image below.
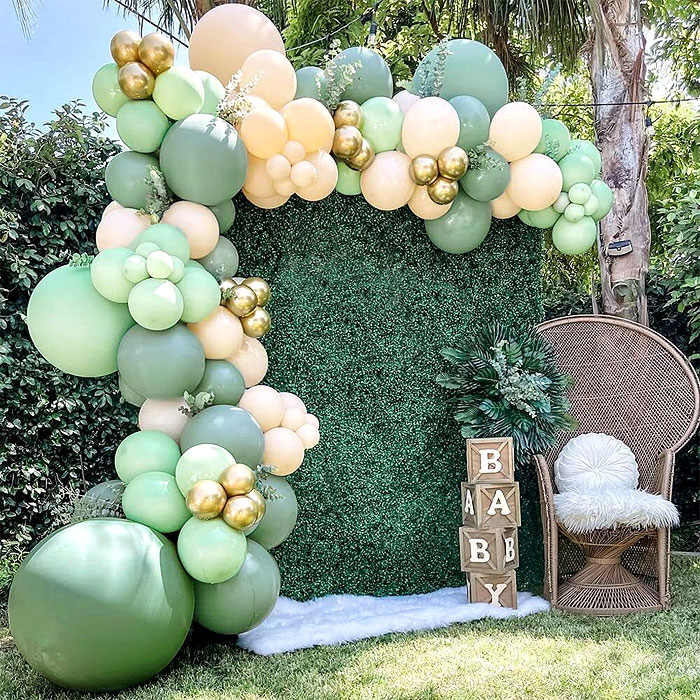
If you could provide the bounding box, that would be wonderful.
[459,527,519,574]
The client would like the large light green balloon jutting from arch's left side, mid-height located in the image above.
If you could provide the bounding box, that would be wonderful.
[27,265,134,377]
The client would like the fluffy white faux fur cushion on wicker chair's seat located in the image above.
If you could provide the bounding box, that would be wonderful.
[554,488,679,532]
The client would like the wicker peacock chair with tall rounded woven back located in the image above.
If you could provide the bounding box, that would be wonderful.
[535,316,700,615]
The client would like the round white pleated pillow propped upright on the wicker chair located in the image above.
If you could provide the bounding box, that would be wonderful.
[554,433,639,493]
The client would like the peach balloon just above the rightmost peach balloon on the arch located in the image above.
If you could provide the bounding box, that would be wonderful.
[489,102,549,163]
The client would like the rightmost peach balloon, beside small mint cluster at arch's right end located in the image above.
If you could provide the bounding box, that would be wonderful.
[506,153,563,211]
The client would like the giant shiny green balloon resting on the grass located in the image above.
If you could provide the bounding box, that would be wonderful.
[9,518,194,692]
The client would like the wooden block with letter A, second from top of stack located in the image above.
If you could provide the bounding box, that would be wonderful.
[462,481,520,528]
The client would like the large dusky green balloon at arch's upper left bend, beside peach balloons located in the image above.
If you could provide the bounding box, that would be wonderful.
[160,115,248,205]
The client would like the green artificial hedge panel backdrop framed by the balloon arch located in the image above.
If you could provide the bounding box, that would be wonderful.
[229,195,542,598]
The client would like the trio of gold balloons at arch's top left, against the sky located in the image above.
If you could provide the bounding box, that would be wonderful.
[109,29,175,100]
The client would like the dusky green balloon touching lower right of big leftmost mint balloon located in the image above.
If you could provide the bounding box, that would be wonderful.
[118,323,204,399]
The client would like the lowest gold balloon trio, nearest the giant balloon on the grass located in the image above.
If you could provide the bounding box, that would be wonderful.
[186,464,265,530]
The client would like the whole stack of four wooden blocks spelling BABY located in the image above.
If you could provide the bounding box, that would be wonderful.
[459,438,520,608]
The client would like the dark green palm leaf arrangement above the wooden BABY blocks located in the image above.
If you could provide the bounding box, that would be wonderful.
[437,323,574,466]
